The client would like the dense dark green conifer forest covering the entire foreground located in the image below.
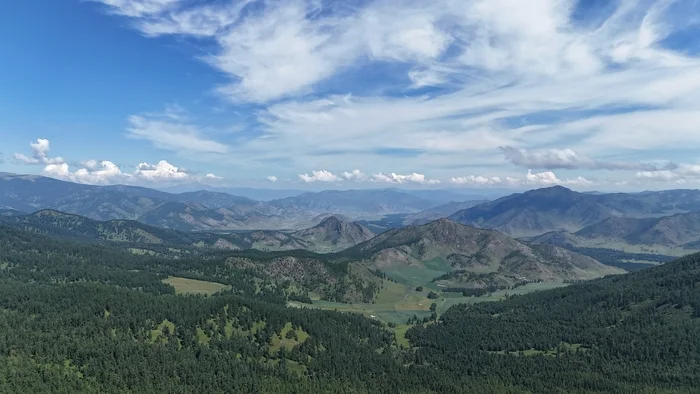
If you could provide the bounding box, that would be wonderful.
[0,226,700,393]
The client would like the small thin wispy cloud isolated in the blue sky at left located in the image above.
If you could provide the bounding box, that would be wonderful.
[126,114,229,154]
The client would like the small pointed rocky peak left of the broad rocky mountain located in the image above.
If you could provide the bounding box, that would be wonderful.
[292,215,374,250]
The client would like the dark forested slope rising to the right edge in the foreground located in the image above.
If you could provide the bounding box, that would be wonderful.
[406,254,700,393]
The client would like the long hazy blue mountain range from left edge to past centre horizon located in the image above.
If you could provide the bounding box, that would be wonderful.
[0,173,446,231]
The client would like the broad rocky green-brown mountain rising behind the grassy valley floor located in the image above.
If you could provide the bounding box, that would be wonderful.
[343,219,624,288]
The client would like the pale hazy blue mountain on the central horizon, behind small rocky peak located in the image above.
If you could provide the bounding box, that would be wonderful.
[270,190,437,219]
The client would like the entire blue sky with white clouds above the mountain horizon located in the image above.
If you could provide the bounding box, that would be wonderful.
[0,0,700,191]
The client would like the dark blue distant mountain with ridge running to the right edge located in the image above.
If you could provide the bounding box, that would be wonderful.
[450,186,700,237]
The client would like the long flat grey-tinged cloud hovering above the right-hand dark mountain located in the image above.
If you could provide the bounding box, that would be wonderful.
[499,146,678,171]
